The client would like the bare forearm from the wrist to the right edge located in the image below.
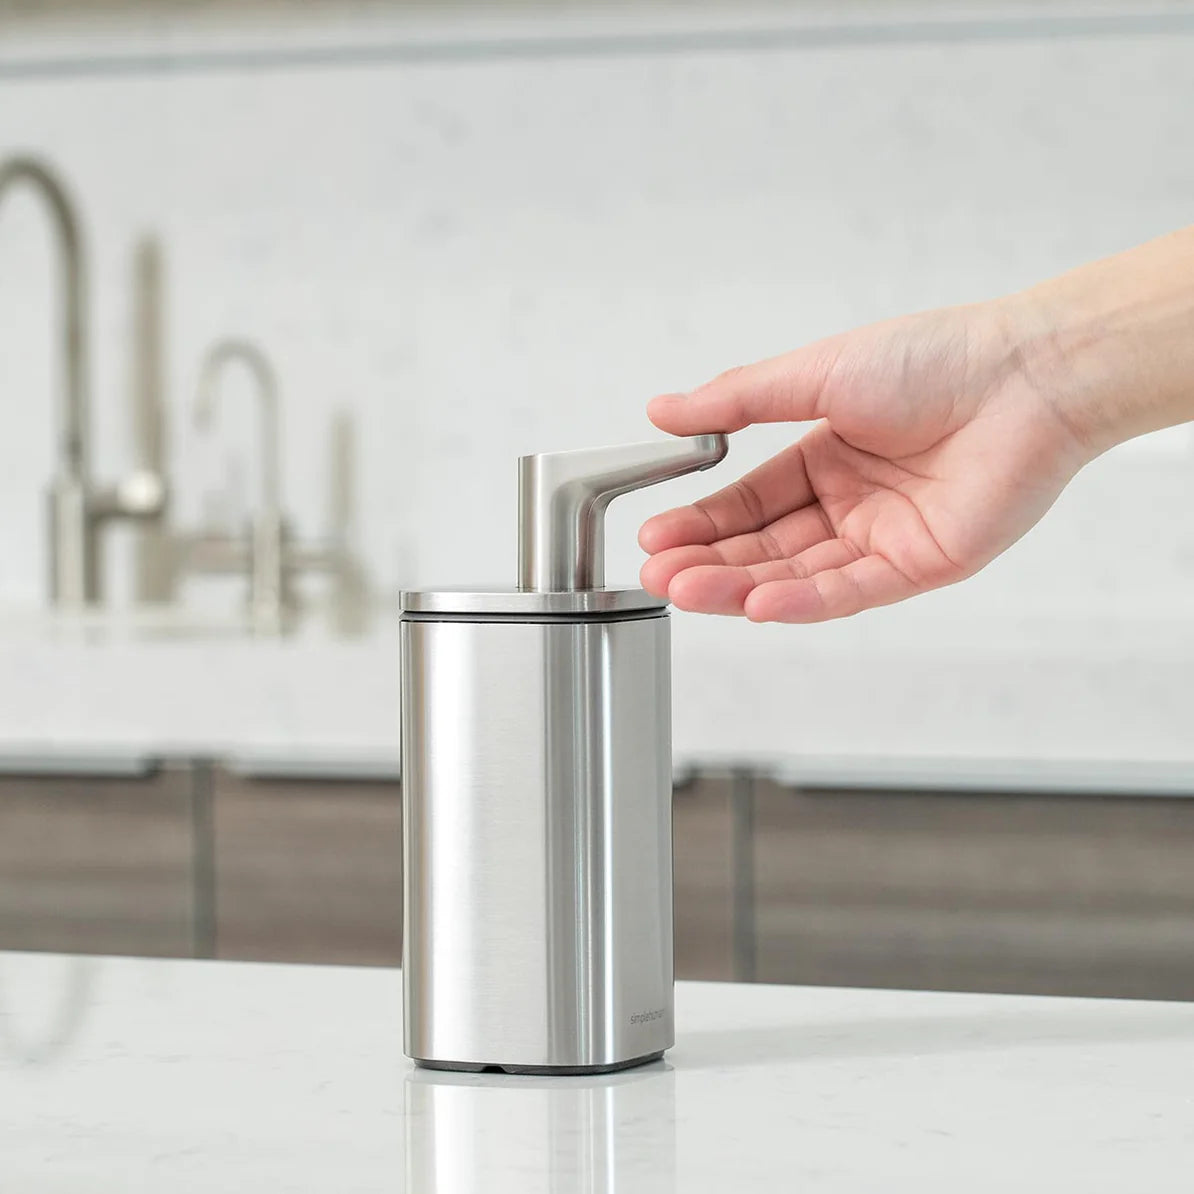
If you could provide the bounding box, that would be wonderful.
[1002,227,1194,455]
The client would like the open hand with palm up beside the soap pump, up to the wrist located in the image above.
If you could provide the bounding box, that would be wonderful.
[639,300,1097,622]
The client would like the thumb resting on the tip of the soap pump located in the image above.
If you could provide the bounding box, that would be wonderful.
[647,341,836,436]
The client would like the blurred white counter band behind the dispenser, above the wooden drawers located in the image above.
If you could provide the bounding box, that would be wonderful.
[7,606,1194,773]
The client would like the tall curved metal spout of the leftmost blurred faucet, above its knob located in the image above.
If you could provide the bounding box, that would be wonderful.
[0,156,87,482]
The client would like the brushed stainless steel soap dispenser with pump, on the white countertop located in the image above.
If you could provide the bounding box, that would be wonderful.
[401,435,726,1073]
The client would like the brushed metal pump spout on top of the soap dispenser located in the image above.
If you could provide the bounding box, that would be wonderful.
[518,435,728,592]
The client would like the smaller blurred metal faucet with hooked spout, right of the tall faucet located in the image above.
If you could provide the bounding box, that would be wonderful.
[195,339,287,634]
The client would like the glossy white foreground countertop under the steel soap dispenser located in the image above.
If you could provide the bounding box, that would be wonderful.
[0,954,1194,1194]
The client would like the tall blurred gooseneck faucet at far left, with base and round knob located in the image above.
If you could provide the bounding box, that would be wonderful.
[0,156,166,609]
